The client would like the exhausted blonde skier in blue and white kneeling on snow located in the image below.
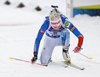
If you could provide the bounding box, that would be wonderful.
[31,6,83,65]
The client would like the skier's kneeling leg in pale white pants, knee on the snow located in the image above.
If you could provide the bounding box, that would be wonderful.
[40,36,58,65]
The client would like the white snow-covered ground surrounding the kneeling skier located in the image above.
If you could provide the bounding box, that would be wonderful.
[0,0,100,77]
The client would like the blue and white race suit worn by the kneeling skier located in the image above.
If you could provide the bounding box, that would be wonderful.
[34,15,82,64]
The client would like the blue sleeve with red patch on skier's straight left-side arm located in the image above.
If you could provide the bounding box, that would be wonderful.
[34,20,49,55]
